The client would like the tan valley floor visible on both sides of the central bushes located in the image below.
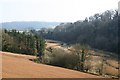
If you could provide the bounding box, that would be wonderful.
[46,40,118,78]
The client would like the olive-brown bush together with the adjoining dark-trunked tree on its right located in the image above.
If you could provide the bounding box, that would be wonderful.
[42,44,90,72]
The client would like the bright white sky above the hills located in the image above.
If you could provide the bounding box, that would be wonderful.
[0,0,119,22]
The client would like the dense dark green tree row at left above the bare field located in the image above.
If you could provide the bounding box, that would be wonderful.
[2,29,45,57]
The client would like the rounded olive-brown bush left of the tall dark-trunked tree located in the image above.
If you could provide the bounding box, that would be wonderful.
[43,49,79,69]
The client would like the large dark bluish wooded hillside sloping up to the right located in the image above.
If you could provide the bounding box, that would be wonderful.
[39,10,118,53]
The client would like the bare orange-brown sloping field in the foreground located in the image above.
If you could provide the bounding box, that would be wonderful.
[0,52,100,78]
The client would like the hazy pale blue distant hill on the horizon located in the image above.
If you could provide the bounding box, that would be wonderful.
[0,21,60,30]
